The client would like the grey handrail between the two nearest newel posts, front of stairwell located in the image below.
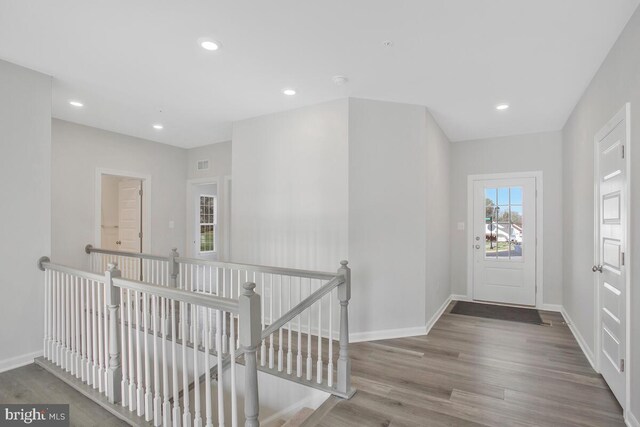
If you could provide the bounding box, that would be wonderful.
[113,277,239,314]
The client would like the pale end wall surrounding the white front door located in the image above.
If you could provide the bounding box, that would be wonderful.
[451,132,563,304]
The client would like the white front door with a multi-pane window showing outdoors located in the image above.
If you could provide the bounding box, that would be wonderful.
[473,177,536,306]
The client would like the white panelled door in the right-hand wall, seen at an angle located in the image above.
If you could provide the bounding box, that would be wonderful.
[593,105,627,405]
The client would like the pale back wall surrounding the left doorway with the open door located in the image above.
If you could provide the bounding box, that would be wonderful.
[51,120,187,268]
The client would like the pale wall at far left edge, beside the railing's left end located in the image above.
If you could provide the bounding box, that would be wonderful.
[0,61,51,371]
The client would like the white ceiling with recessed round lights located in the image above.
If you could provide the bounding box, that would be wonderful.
[0,0,640,148]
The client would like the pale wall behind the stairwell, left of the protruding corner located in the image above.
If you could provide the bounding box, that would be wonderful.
[231,99,348,271]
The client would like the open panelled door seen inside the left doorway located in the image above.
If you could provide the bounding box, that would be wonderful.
[116,179,143,252]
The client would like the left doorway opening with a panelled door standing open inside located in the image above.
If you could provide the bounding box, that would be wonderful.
[95,170,150,253]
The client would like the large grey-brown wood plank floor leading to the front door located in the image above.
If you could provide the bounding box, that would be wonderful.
[304,307,624,427]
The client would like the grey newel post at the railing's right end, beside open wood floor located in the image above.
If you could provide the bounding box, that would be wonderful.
[336,261,351,394]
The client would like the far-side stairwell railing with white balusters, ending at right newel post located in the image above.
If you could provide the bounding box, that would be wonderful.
[86,245,353,398]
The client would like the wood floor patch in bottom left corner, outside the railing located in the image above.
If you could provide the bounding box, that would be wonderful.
[0,364,128,427]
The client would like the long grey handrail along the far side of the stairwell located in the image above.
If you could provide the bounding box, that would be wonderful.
[85,244,336,280]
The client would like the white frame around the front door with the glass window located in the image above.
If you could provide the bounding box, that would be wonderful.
[467,171,544,311]
